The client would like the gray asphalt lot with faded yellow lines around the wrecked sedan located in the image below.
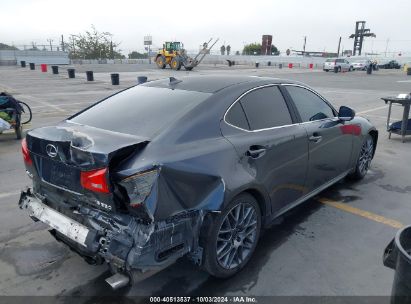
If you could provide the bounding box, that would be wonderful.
[0,64,411,302]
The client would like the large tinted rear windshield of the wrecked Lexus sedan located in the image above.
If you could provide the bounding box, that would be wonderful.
[69,86,211,138]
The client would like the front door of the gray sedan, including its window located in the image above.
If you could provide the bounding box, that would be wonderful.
[285,85,353,191]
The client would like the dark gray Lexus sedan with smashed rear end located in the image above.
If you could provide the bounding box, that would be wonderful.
[19,76,378,288]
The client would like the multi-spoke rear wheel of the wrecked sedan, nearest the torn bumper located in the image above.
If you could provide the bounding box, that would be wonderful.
[203,193,261,278]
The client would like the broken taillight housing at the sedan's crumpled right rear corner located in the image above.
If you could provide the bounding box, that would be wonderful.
[120,170,158,208]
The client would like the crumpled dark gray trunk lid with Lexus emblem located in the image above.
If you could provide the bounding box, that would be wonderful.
[26,121,149,202]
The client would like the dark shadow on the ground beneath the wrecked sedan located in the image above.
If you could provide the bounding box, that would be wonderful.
[61,199,324,304]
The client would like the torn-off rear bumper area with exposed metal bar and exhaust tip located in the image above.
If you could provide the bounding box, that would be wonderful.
[19,189,203,287]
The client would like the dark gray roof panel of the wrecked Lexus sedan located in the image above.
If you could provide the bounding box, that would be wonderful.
[143,75,299,93]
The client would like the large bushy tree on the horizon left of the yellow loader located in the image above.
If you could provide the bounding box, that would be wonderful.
[68,25,125,59]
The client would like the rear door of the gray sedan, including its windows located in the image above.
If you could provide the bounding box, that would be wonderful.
[222,86,308,213]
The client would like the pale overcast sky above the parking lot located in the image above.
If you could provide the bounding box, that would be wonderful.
[0,0,411,55]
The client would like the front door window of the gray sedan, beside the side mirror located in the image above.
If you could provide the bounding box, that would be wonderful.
[287,86,335,122]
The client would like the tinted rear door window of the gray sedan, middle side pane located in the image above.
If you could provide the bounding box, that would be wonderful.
[240,86,292,130]
